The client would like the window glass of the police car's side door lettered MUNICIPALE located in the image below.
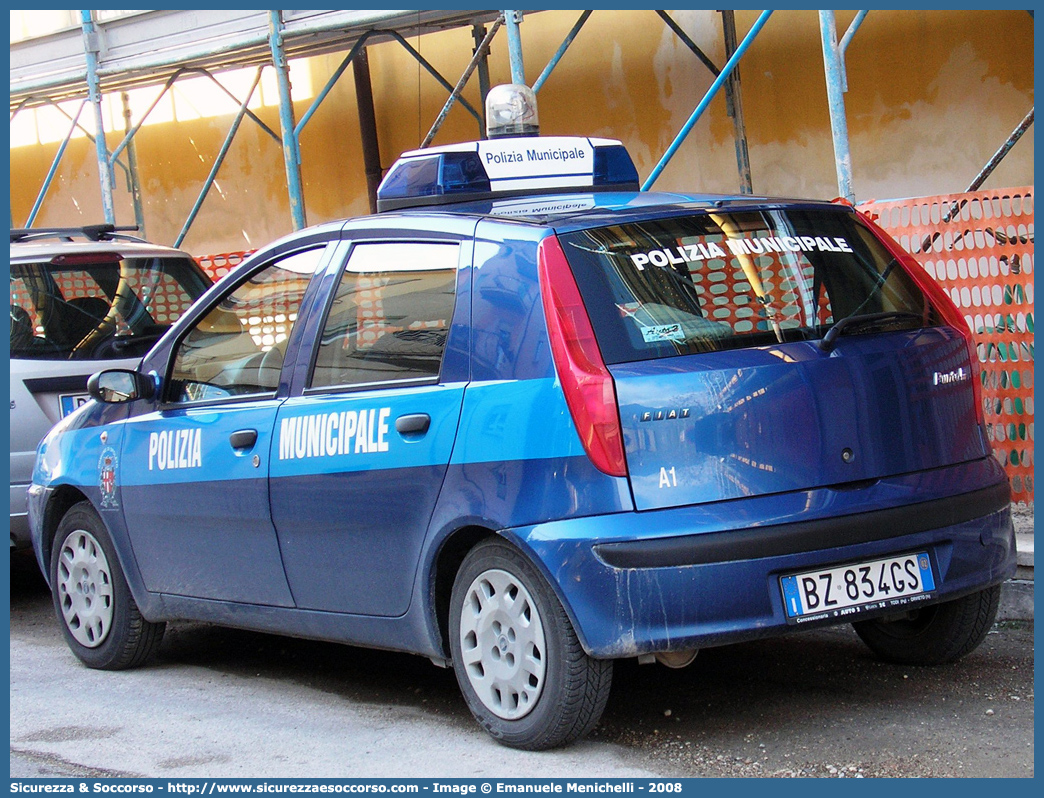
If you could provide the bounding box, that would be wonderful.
[309,242,459,389]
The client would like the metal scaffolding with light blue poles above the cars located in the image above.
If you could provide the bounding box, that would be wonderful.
[10,9,1033,245]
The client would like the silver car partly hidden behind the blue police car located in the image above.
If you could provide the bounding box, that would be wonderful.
[10,225,211,550]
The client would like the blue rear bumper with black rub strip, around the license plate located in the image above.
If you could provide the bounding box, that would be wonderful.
[508,457,1016,658]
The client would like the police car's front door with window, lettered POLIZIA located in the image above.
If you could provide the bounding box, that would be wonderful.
[120,248,324,607]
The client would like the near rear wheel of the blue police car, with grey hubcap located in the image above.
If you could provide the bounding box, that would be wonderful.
[449,539,613,751]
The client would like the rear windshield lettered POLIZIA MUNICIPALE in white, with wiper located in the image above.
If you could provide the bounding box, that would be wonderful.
[561,209,939,363]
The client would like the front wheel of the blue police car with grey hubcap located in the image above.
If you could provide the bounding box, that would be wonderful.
[50,501,166,671]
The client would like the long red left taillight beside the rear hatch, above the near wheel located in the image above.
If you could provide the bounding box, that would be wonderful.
[537,235,627,476]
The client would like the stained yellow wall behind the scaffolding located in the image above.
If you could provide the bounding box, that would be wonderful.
[11,10,1034,255]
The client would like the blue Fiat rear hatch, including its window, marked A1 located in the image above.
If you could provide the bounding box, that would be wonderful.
[560,206,989,510]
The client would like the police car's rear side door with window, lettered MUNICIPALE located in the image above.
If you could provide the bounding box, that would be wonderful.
[271,237,472,615]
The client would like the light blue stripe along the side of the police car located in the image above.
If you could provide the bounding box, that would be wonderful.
[38,379,585,486]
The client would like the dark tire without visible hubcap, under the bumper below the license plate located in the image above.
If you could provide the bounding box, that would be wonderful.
[852,585,1000,665]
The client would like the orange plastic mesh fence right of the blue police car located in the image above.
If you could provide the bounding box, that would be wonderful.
[859,187,1034,503]
